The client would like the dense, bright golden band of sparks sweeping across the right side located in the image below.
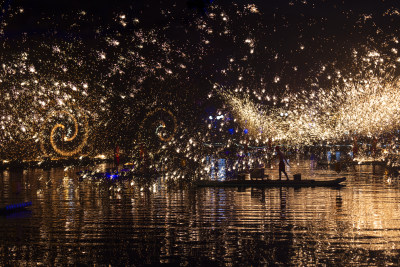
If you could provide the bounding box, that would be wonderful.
[219,75,400,144]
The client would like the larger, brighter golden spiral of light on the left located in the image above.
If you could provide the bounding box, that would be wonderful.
[40,109,89,157]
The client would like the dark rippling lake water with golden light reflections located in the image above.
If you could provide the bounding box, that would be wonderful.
[0,161,400,266]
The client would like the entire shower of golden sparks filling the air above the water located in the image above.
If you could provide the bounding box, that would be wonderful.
[0,1,400,178]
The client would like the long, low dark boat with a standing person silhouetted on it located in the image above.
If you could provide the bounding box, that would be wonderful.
[195,177,346,187]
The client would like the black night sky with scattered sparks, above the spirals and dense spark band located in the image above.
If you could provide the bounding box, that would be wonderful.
[0,0,400,159]
